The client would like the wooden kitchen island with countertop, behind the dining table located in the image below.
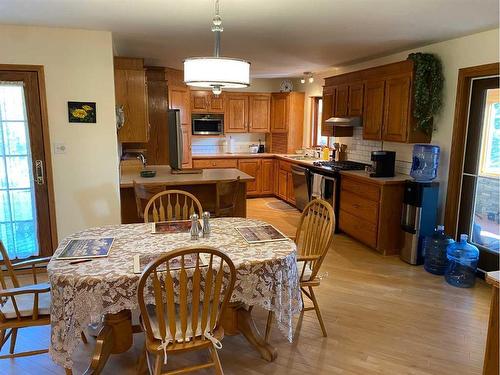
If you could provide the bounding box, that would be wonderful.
[120,165,254,224]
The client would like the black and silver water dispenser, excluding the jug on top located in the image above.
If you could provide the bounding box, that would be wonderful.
[400,181,439,265]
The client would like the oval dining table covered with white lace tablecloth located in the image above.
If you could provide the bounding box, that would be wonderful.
[48,217,302,374]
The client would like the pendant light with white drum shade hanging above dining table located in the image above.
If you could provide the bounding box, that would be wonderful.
[184,0,250,95]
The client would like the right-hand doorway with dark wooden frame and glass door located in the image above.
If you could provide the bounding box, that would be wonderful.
[445,63,500,271]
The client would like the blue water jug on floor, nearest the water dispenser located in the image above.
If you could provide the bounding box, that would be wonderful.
[424,225,454,275]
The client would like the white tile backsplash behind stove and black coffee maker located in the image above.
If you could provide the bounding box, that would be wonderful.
[334,128,413,174]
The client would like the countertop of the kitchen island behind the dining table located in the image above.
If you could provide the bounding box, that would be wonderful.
[120,165,254,188]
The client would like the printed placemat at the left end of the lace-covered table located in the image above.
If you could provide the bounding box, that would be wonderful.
[57,237,114,259]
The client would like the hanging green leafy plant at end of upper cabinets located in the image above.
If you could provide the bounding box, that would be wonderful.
[408,52,444,134]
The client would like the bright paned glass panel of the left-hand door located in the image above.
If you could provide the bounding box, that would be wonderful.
[0,82,39,259]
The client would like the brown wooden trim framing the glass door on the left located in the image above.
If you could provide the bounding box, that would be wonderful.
[0,64,58,256]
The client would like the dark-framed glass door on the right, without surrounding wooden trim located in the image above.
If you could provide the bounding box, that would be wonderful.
[458,77,500,271]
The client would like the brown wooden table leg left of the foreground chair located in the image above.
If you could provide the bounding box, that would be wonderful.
[84,310,133,375]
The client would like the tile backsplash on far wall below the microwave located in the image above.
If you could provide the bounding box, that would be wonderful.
[191,133,266,155]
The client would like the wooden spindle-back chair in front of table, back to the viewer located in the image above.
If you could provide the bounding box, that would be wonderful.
[137,247,236,375]
